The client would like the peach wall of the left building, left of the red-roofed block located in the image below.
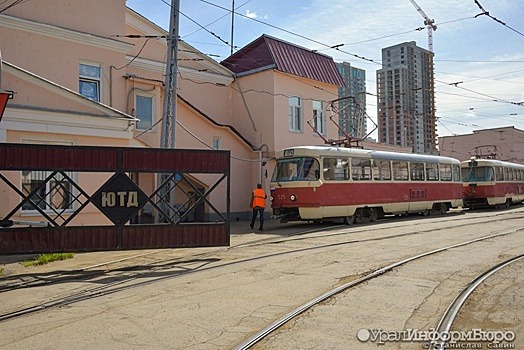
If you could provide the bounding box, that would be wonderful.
[0,0,259,224]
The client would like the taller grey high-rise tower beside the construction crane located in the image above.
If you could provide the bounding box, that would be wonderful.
[377,41,437,154]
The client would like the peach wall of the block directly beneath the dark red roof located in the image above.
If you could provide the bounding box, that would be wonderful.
[230,70,338,151]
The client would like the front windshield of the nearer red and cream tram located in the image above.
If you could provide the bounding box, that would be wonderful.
[271,157,320,182]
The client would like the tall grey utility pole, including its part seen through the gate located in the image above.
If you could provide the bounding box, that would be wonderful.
[157,0,180,222]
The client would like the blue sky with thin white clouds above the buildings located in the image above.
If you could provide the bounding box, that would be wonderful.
[126,0,524,138]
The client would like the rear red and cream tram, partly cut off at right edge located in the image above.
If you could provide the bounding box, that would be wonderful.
[460,159,524,208]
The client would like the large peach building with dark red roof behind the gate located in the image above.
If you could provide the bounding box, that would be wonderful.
[0,0,350,224]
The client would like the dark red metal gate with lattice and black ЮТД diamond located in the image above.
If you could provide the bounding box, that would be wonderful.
[0,143,230,254]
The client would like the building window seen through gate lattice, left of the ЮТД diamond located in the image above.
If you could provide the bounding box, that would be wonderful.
[22,171,74,213]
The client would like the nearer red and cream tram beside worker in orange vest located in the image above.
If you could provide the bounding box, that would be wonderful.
[270,146,462,223]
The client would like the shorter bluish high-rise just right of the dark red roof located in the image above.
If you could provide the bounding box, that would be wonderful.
[337,62,367,138]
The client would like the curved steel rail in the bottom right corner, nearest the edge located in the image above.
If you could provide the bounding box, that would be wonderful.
[430,254,524,350]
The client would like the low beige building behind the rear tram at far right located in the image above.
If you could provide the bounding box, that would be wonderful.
[439,126,524,164]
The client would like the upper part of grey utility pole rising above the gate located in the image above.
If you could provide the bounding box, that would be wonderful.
[160,0,180,148]
